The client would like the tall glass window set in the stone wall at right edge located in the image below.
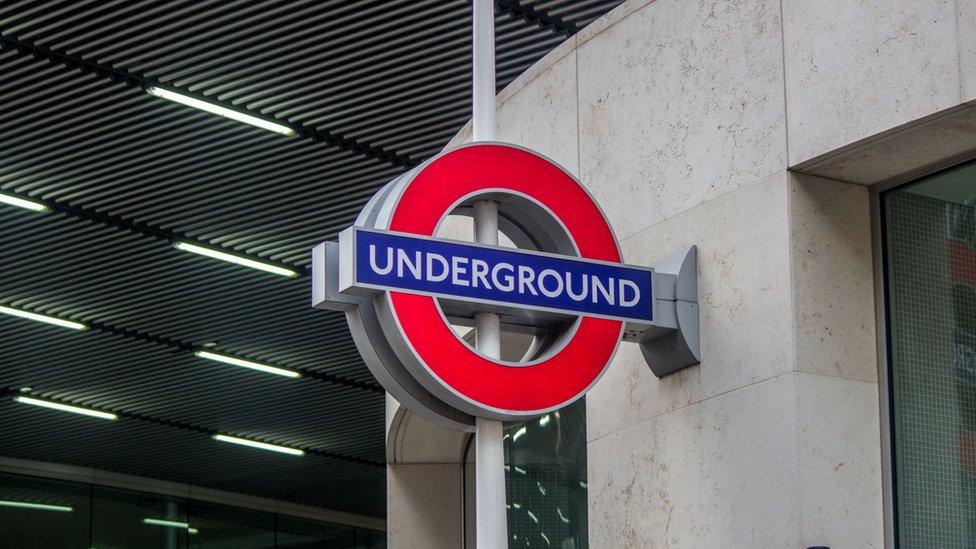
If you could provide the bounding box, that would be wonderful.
[882,158,976,547]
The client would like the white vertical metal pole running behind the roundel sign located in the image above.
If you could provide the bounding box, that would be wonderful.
[472,0,508,549]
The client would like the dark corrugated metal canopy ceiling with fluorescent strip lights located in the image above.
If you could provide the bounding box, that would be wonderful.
[0,0,619,516]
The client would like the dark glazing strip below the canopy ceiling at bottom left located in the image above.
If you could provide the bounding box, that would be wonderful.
[0,468,386,549]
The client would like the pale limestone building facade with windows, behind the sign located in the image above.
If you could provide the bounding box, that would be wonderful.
[387,0,976,548]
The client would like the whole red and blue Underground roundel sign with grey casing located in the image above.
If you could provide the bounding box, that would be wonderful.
[313,143,692,428]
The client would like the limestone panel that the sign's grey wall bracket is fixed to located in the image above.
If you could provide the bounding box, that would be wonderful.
[587,171,794,440]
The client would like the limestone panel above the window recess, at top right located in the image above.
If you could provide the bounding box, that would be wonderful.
[782,0,972,166]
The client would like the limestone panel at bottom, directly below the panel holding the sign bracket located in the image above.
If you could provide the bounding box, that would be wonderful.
[587,374,800,549]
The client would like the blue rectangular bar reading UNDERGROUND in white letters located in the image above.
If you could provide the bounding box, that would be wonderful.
[353,228,654,322]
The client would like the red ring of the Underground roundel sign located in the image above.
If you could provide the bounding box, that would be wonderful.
[390,143,623,415]
